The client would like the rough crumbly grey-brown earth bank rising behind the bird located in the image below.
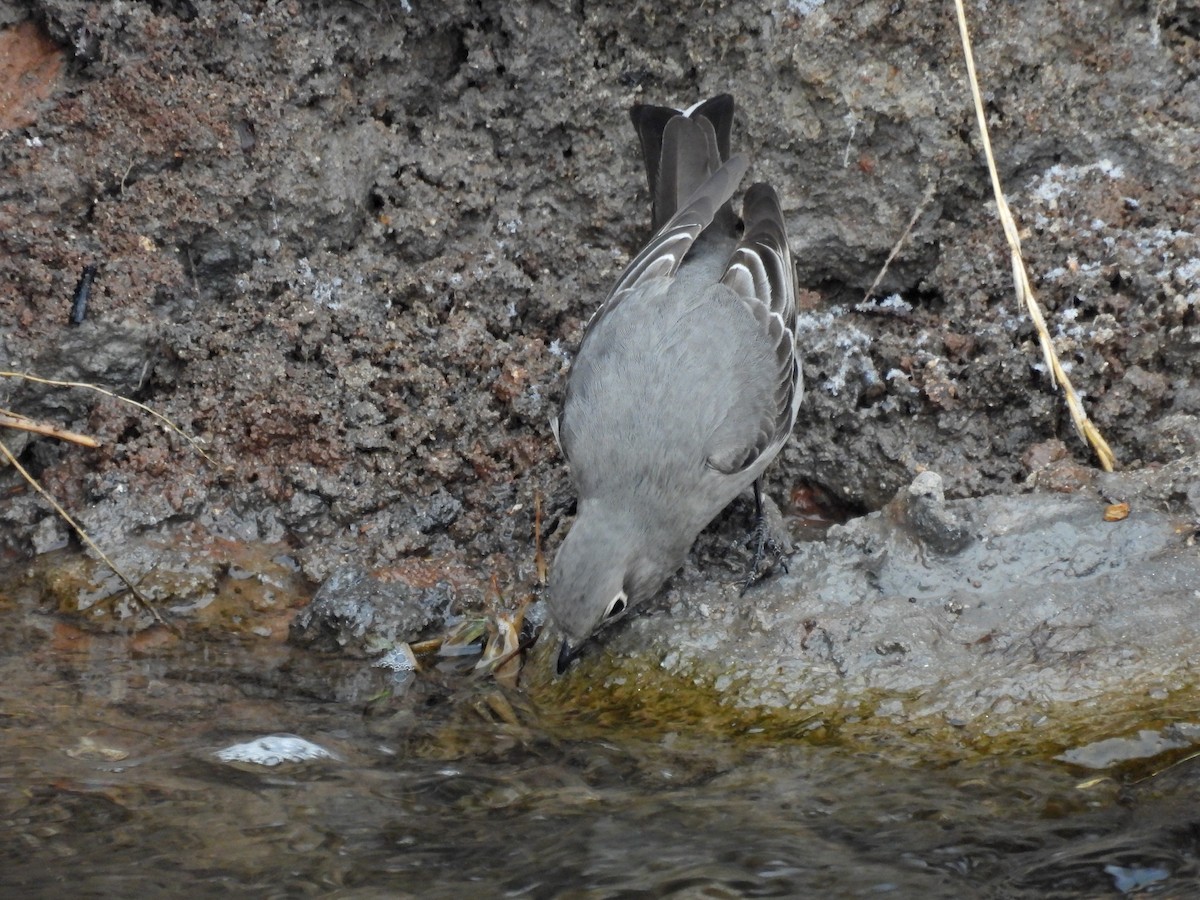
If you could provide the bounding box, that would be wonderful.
[0,0,1200,586]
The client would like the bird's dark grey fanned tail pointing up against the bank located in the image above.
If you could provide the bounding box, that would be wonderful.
[629,94,733,230]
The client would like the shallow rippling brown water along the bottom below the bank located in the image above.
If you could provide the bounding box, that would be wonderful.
[0,578,1200,898]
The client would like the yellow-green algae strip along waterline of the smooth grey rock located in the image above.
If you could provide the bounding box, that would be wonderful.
[523,653,1200,775]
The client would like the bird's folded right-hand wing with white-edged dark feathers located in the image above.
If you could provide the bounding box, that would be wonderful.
[709,184,804,474]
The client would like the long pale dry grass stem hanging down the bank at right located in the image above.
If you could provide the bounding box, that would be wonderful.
[954,0,1116,472]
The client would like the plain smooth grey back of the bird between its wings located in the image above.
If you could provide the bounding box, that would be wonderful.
[559,271,775,528]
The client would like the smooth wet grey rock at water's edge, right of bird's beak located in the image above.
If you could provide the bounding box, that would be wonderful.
[549,457,1200,733]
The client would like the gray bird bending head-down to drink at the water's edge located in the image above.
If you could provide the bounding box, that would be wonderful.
[550,95,803,673]
